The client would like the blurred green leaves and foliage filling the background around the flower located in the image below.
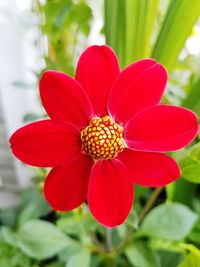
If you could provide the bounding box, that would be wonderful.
[0,0,200,267]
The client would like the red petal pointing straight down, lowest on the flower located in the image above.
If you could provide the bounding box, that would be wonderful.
[88,160,133,227]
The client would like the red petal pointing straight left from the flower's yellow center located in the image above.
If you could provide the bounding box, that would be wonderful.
[10,120,81,167]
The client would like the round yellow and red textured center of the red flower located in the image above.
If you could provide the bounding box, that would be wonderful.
[81,116,125,160]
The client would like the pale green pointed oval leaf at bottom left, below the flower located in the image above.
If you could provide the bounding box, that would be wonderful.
[17,220,71,260]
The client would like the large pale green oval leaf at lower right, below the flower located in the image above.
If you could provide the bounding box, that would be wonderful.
[141,203,197,240]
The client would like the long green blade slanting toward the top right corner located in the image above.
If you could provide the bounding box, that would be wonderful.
[152,0,200,71]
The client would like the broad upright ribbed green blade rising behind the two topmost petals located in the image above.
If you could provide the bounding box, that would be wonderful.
[104,0,158,68]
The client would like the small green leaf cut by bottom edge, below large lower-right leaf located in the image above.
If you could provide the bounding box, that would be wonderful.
[125,241,160,267]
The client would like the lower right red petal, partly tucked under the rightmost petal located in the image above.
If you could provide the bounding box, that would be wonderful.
[118,149,180,187]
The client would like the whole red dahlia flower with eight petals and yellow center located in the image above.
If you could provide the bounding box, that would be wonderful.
[10,46,198,227]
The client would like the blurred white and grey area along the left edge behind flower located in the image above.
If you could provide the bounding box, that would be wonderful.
[0,0,43,208]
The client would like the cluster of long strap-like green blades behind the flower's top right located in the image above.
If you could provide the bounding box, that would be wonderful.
[104,0,200,71]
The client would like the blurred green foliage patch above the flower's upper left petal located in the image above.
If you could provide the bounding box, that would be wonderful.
[35,0,92,75]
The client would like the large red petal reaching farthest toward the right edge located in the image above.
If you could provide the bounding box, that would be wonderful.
[124,105,198,152]
